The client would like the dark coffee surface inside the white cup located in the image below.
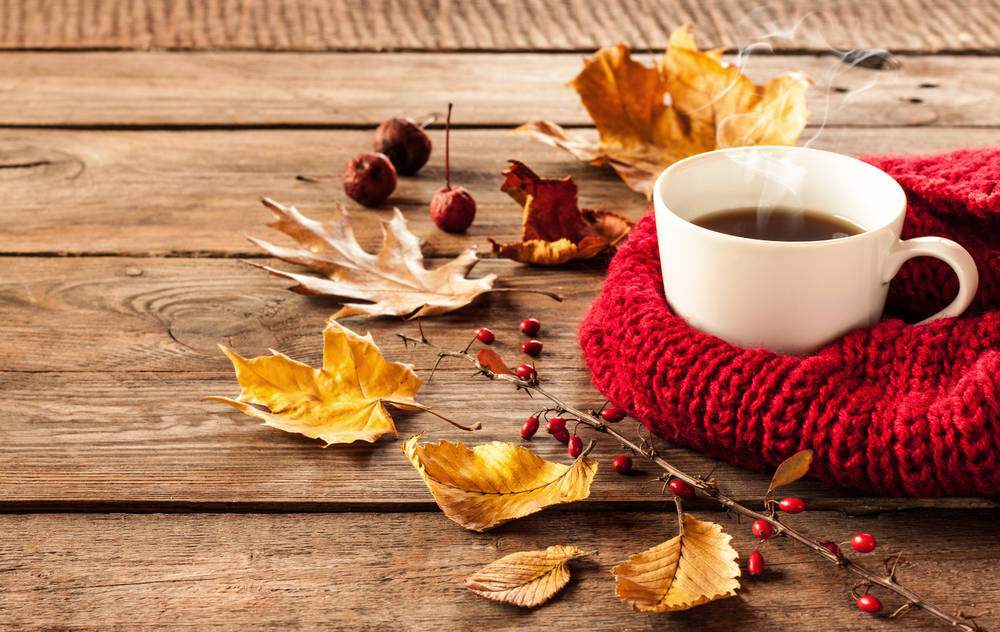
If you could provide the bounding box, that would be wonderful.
[692,206,865,241]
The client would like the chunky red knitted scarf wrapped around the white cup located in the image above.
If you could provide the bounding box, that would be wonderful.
[580,148,1000,497]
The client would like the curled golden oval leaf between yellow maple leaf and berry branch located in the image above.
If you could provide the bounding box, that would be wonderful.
[403,435,597,531]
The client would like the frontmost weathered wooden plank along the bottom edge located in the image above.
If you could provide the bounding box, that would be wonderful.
[0,511,1000,632]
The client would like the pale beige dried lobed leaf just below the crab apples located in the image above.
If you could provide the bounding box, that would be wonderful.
[247,199,496,318]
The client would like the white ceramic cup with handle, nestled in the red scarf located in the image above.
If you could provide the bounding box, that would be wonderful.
[653,146,979,355]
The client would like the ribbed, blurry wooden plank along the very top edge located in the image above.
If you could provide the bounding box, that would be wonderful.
[0,0,1000,51]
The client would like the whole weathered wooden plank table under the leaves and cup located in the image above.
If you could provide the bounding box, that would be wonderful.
[0,0,1000,632]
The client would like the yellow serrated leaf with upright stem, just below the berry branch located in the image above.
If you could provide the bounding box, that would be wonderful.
[611,514,740,612]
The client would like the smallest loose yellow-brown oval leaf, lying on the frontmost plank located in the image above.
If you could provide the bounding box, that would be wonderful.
[465,546,584,608]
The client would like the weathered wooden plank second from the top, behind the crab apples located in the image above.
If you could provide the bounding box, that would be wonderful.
[0,51,1000,127]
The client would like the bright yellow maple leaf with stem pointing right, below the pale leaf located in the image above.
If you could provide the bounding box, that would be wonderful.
[205,320,426,445]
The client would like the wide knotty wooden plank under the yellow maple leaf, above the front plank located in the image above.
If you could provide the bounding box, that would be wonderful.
[0,257,991,512]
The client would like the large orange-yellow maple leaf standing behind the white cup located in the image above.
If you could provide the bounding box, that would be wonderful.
[515,26,810,196]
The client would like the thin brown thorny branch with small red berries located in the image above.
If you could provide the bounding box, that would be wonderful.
[397,326,983,632]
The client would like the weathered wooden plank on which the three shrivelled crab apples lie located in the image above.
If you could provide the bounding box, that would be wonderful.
[0,128,1000,256]
